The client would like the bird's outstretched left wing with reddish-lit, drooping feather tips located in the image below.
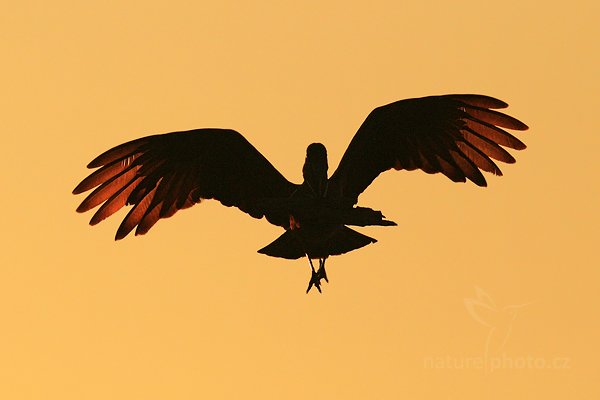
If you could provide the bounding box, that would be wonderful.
[73,129,296,240]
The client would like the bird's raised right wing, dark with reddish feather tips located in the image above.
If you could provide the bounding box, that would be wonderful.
[329,94,527,201]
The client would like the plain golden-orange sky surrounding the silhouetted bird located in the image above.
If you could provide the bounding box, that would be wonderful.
[0,0,600,399]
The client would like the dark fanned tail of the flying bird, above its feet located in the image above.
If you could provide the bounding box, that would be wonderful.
[258,226,377,260]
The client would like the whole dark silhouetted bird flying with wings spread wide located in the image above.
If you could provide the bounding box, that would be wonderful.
[73,94,528,293]
